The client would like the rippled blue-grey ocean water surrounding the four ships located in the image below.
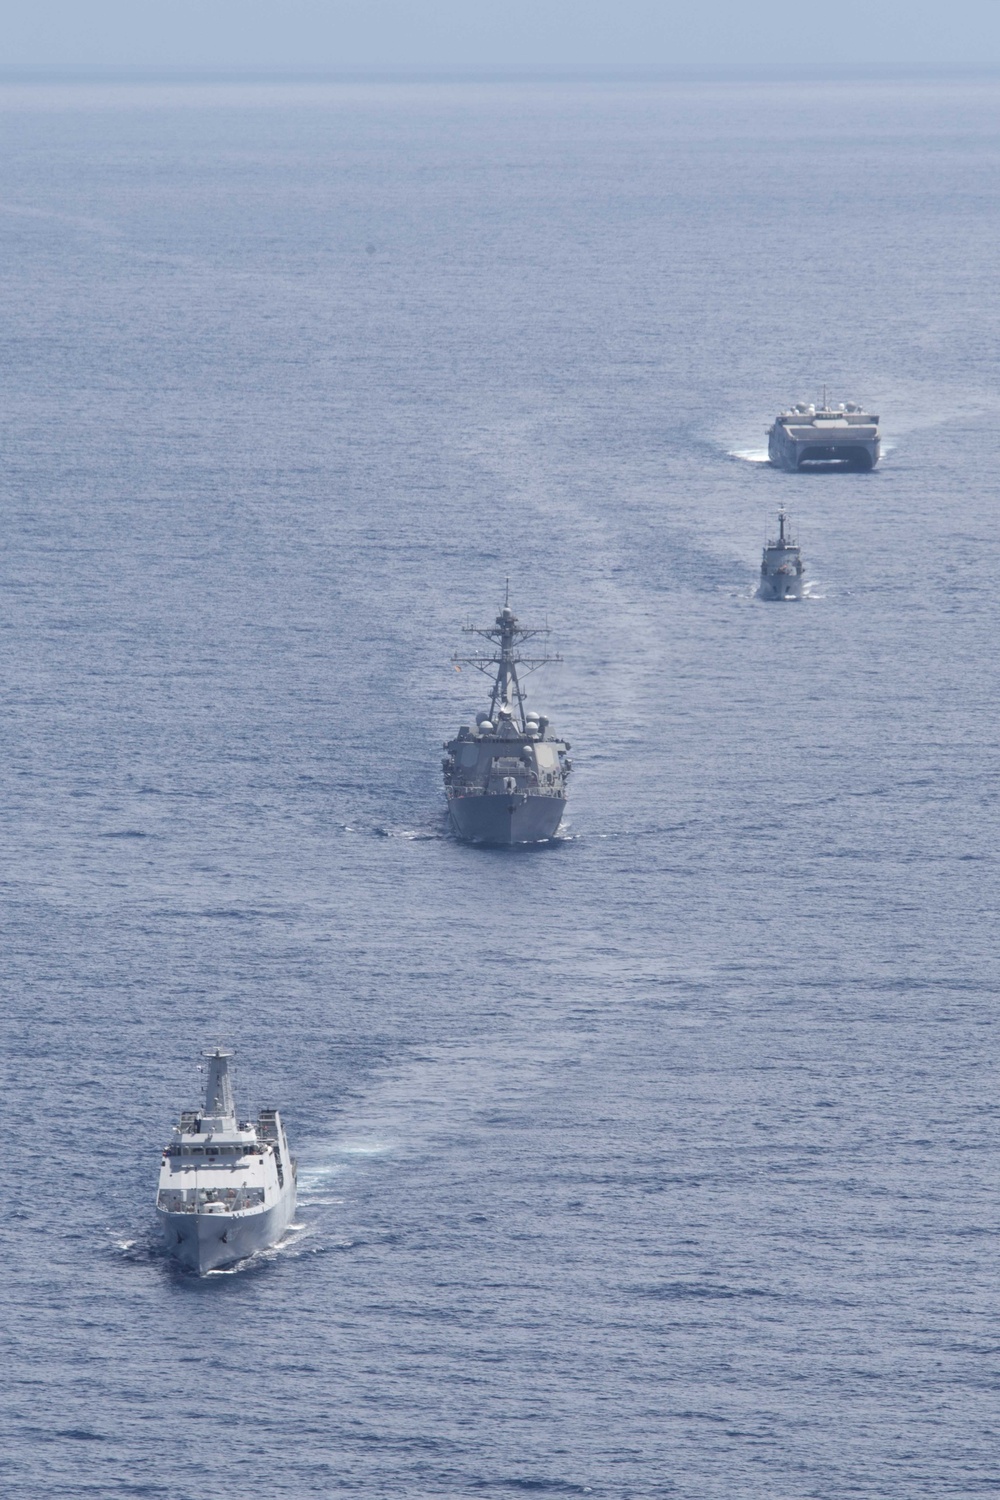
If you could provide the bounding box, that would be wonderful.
[0,80,1000,1500]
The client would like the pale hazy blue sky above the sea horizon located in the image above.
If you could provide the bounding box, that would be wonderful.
[0,0,1000,74]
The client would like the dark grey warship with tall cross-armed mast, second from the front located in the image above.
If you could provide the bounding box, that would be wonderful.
[442,594,571,845]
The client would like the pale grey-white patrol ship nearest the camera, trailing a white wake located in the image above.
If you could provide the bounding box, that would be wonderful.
[156,1047,295,1275]
